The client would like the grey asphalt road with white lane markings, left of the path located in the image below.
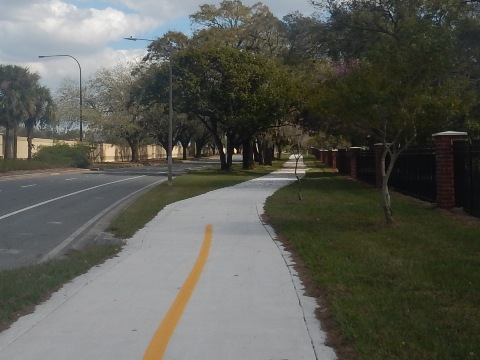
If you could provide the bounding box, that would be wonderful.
[0,162,215,270]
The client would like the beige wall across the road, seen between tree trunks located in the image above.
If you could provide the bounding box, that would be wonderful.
[0,133,182,162]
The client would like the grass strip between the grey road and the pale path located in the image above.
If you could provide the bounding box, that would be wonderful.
[0,160,284,331]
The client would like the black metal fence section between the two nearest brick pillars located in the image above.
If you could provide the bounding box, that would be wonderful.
[390,145,437,202]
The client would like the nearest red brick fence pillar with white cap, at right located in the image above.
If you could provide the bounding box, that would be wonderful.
[433,131,467,209]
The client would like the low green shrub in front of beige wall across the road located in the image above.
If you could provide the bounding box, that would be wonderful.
[33,144,90,168]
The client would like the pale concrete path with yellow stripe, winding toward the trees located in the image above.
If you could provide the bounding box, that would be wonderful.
[0,158,335,360]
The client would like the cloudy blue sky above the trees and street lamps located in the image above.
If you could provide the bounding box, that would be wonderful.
[0,0,315,91]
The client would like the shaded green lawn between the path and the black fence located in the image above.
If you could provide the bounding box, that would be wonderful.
[266,161,480,360]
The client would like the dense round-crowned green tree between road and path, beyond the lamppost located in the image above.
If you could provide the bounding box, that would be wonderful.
[174,47,296,170]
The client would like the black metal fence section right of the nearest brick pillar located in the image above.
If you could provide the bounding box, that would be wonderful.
[453,140,480,217]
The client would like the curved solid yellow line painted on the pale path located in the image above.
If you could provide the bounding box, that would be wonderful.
[143,224,212,360]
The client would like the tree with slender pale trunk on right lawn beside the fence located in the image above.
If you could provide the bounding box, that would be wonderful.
[314,0,472,222]
